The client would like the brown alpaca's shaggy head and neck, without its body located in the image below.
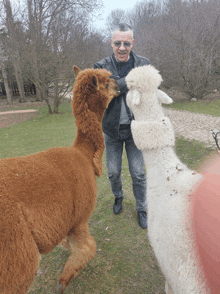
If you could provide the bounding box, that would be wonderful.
[72,66,119,176]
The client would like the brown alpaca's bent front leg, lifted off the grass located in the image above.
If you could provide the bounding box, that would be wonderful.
[57,223,96,294]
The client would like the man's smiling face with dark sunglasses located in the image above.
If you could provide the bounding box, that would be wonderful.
[111,30,134,62]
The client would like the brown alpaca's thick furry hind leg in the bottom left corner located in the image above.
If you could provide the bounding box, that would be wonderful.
[0,225,40,294]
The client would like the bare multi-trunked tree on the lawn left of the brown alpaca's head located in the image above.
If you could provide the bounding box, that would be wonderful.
[21,0,102,113]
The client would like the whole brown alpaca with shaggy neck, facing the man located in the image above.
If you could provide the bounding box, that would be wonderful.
[0,67,117,294]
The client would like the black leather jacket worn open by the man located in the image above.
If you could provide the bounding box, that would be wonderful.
[94,51,150,138]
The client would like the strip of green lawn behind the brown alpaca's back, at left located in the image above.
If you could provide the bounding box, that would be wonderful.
[0,103,76,158]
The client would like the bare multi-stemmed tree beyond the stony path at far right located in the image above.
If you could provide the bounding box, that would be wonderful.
[164,0,220,98]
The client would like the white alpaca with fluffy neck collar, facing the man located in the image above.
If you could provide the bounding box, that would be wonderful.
[126,65,210,294]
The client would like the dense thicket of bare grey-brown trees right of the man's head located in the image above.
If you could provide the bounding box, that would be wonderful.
[131,0,220,98]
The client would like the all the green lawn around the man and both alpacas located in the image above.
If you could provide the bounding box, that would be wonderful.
[0,99,217,294]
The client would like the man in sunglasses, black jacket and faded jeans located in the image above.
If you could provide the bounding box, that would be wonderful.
[94,24,150,229]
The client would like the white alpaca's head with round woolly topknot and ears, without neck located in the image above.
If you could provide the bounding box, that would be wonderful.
[125,65,173,120]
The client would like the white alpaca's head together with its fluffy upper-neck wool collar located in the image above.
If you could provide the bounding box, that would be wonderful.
[125,65,175,151]
